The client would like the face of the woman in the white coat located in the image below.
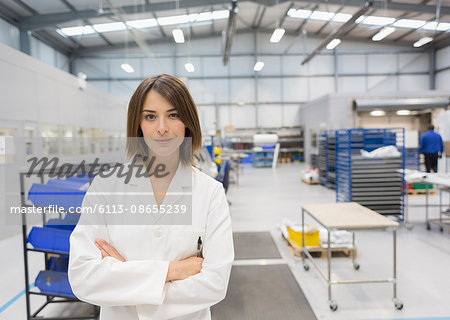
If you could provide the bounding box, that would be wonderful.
[140,90,186,156]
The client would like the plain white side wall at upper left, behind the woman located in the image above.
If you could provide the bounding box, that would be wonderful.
[0,44,126,132]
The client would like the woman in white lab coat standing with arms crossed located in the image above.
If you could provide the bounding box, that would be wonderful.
[68,74,234,320]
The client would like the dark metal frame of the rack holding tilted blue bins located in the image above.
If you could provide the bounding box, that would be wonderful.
[20,169,100,320]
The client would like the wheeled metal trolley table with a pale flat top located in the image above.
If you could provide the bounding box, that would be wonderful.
[302,202,403,311]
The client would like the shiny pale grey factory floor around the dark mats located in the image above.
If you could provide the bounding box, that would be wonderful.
[0,164,450,320]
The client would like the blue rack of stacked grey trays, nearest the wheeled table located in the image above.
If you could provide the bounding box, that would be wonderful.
[336,128,405,221]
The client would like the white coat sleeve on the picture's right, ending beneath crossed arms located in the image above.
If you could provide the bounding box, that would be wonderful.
[147,184,234,319]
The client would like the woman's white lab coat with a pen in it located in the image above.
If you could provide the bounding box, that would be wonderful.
[68,166,234,320]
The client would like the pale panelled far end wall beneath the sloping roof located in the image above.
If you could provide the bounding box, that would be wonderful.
[74,33,450,130]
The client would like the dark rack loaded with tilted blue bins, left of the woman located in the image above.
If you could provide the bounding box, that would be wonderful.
[20,170,100,320]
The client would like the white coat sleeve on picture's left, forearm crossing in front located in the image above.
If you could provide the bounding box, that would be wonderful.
[68,179,169,306]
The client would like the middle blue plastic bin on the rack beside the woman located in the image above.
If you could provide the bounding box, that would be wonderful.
[28,227,72,254]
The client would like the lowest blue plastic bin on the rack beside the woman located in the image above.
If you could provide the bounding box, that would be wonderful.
[35,270,76,298]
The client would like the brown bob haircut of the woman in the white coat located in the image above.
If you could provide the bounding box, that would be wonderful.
[126,74,202,165]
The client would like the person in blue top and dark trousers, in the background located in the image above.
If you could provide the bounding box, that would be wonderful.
[420,124,444,172]
